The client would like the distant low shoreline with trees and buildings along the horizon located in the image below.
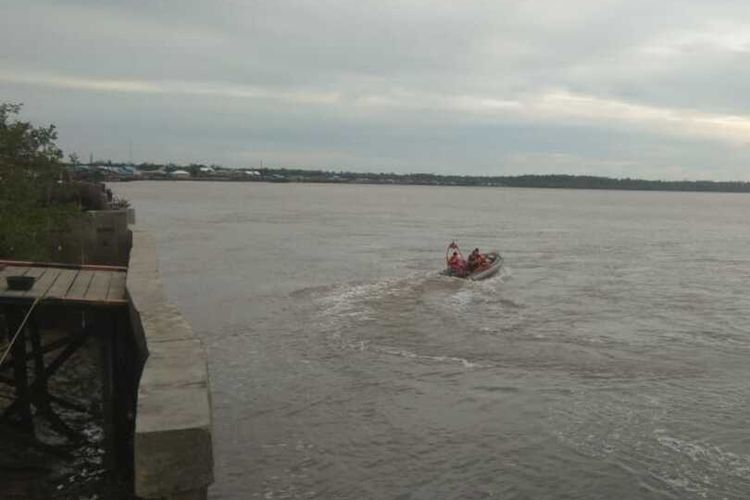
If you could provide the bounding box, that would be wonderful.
[75,164,750,193]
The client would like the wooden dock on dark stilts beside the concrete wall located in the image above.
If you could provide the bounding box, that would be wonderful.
[0,260,137,488]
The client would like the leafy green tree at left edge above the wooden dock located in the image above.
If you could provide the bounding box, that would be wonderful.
[0,103,80,260]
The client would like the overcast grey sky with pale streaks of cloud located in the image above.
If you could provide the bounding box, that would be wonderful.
[0,0,750,181]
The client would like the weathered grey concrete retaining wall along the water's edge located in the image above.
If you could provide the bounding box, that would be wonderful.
[127,229,213,499]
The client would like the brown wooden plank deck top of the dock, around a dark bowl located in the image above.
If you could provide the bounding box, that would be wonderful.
[0,261,127,305]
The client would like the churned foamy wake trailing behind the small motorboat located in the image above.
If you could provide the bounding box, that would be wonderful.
[306,272,518,362]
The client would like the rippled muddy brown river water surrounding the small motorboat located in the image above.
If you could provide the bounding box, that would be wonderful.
[114,182,750,500]
